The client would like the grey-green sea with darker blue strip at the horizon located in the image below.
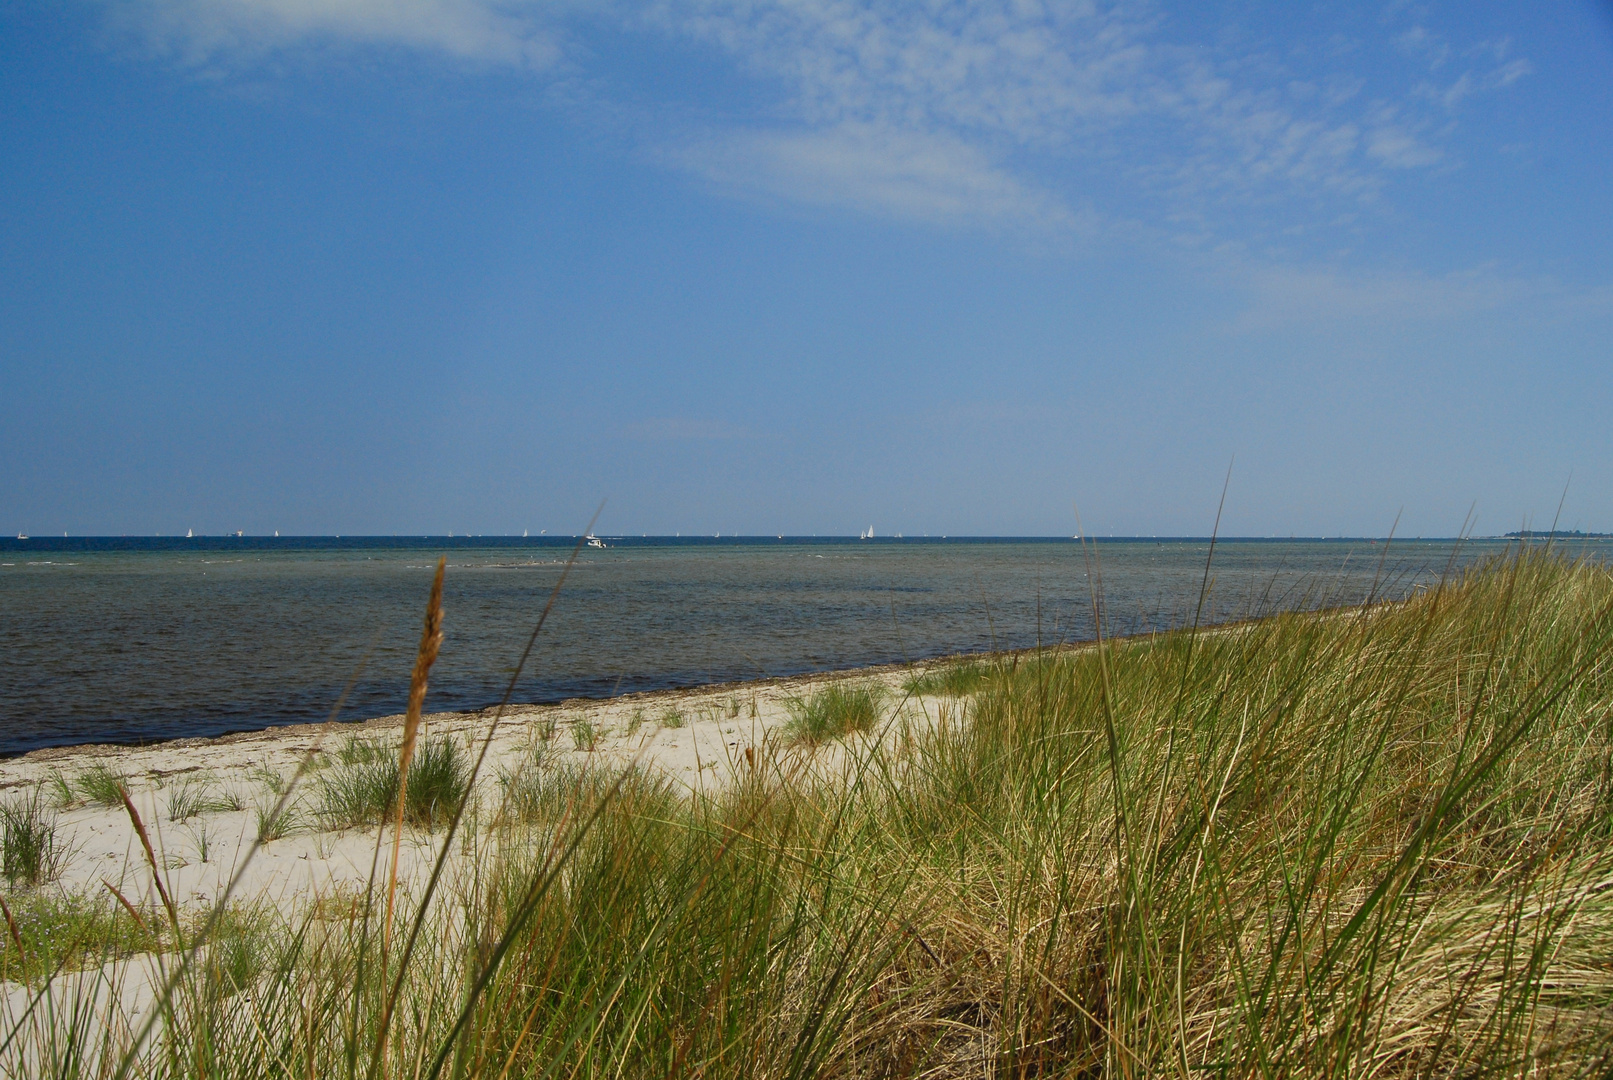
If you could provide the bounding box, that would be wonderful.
[0,537,1587,754]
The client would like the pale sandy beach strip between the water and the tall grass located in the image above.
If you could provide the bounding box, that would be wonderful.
[0,666,942,914]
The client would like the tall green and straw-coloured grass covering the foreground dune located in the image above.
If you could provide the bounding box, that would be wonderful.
[0,550,1613,1080]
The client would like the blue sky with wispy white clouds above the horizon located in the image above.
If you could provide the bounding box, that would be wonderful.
[0,0,1613,535]
